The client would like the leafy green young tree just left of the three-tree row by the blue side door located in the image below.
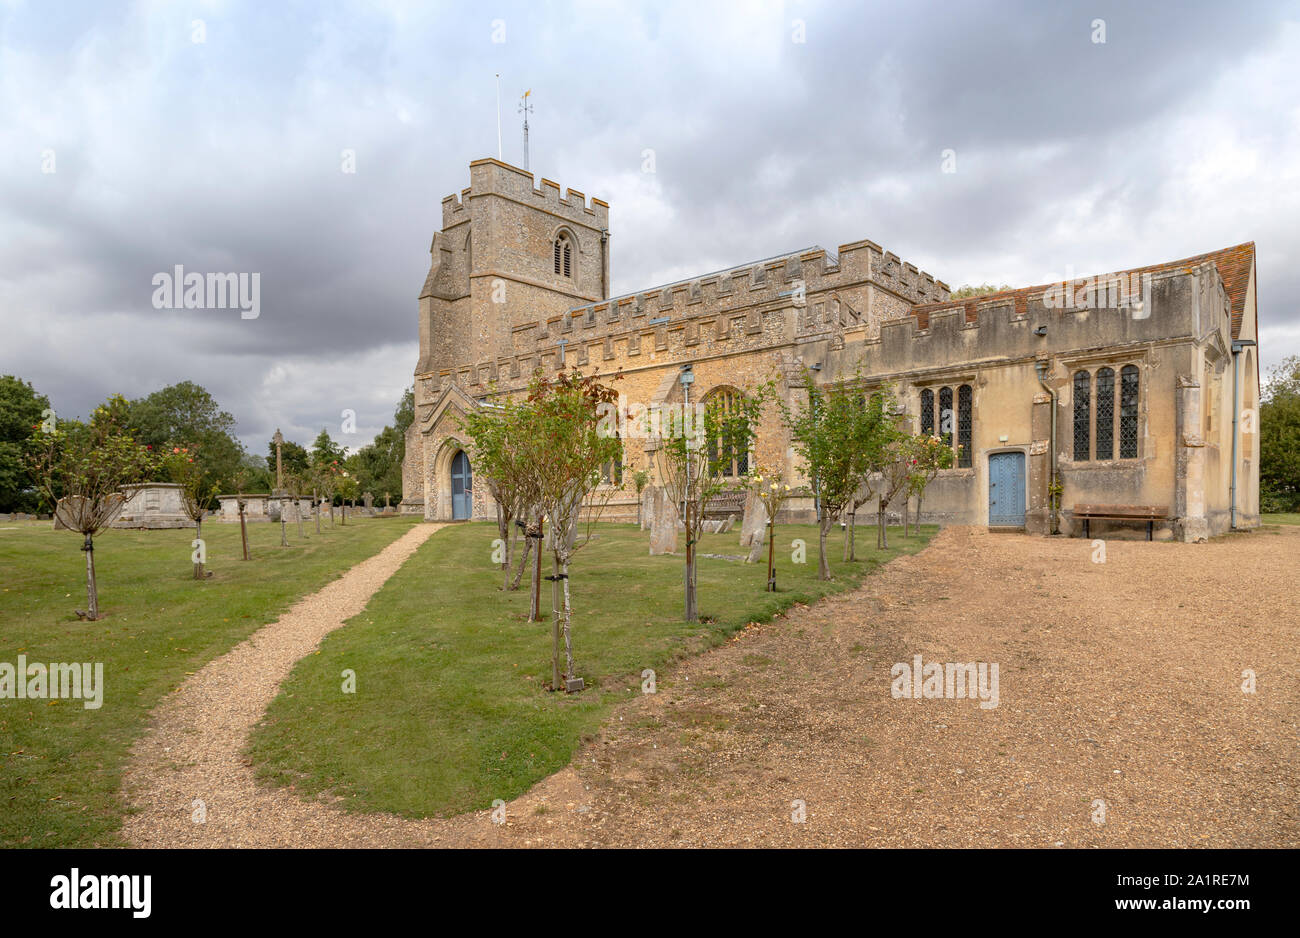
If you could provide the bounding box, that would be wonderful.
[781,372,888,579]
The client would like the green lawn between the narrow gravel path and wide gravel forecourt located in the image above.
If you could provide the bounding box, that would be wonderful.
[251,524,936,817]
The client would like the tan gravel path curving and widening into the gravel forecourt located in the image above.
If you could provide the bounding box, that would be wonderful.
[125,526,1300,847]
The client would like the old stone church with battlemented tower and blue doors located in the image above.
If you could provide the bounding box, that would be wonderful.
[402,158,1260,540]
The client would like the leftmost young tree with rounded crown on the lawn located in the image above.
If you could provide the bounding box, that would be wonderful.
[26,395,157,621]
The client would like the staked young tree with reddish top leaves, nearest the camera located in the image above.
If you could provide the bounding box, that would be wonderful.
[521,369,623,692]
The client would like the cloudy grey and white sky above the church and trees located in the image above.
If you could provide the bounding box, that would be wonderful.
[0,0,1300,453]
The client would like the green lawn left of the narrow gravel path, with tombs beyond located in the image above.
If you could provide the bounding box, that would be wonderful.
[0,518,412,847]
